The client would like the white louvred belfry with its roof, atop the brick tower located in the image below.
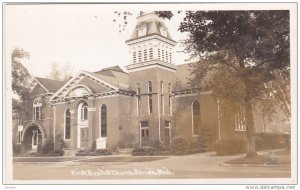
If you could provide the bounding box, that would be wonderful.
[126,12,176,72]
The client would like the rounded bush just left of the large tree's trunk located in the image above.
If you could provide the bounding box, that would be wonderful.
[214,138,247,156]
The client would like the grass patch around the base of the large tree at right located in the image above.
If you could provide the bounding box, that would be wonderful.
[225,150,291,165]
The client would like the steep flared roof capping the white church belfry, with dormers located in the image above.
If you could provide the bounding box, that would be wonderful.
[126,13,175,42]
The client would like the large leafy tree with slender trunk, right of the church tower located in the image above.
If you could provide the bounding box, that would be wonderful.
[179,11,290,157]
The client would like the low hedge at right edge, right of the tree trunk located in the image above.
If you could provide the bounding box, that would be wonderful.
[255,133,290,150]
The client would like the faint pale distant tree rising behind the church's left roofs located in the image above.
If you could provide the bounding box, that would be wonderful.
[48,62,74,81]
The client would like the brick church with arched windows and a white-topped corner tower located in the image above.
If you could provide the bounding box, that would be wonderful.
[13,13,284,153]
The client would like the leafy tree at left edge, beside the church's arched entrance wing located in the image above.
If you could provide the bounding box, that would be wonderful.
[11,48,31,115]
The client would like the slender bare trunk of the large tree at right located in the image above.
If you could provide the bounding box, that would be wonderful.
[244,98,257,157]
